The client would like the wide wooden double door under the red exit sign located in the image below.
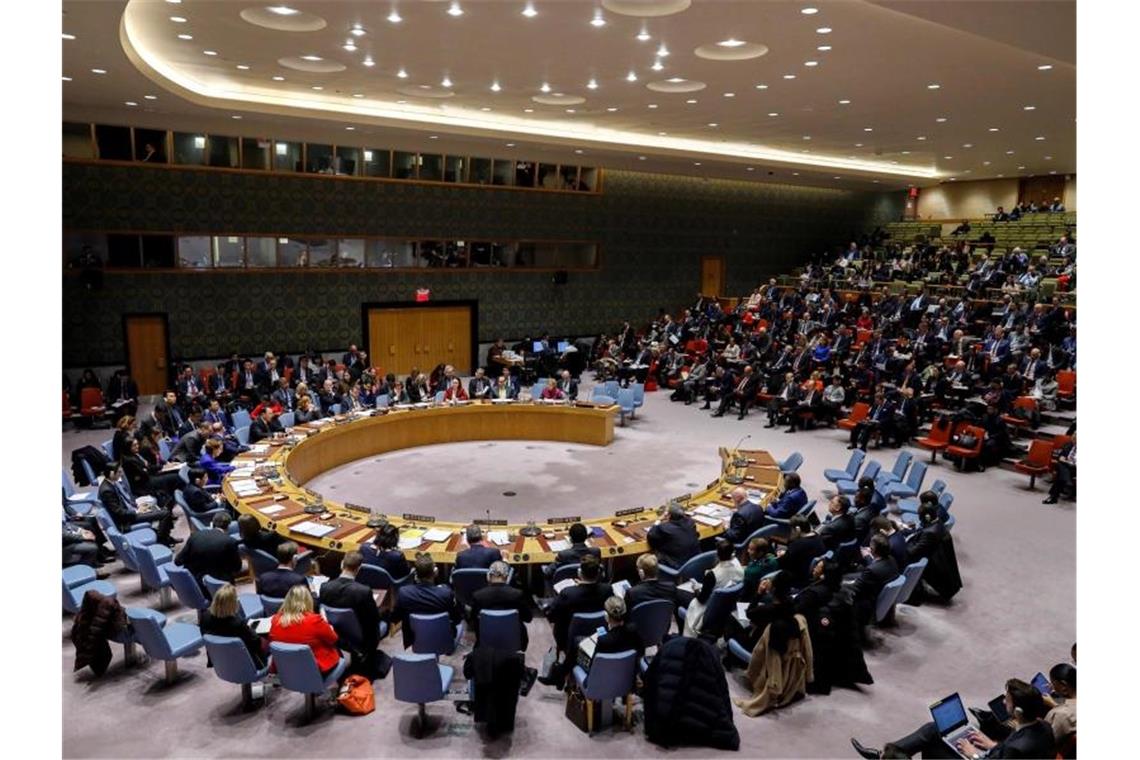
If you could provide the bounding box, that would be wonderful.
[367,304,474,375]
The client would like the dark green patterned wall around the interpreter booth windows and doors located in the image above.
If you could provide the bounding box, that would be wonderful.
[63,163,903,366]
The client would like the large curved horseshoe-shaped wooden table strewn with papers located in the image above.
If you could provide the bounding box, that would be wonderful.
[222,402,780,564]
